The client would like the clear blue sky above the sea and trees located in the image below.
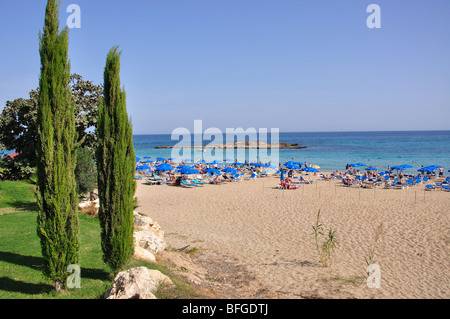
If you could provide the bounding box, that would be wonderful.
[0,0,450,134]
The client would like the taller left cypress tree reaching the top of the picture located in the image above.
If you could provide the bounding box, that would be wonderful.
[36,0,80,291]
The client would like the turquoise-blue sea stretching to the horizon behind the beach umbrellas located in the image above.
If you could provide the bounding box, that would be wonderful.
[134,131,450,175]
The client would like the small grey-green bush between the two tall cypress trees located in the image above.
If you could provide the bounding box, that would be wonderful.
[75,148,97,195]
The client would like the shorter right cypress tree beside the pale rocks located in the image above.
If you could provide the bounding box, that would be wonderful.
[96,47,136,273]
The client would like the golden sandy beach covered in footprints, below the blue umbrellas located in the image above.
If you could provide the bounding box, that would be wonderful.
[136,175,450,299]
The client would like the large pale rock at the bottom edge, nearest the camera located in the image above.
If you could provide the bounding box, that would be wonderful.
[105,267,173,299]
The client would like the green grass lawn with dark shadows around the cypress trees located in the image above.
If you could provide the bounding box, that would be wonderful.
[0,181,199,299]
